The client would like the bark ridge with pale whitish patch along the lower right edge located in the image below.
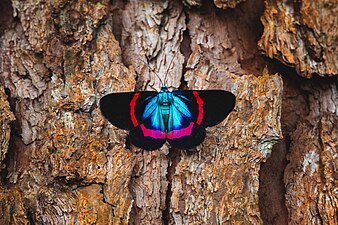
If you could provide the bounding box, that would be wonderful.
[282,78,338,224]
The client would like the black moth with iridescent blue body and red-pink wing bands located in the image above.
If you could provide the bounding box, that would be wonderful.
[100,87,236,150]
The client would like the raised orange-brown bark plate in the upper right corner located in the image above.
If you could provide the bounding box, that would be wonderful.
[258,0,338,78]
